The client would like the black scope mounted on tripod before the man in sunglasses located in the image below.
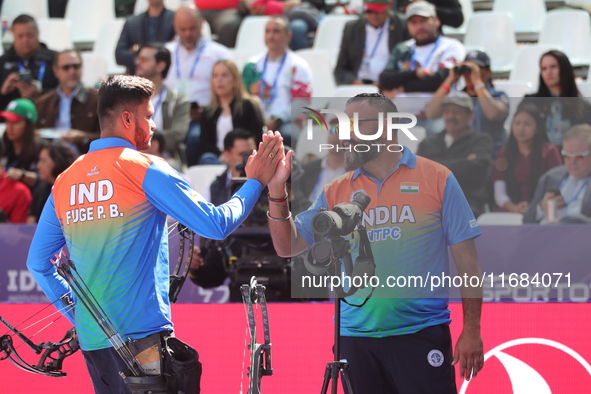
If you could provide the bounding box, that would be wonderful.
[312,191,371,236]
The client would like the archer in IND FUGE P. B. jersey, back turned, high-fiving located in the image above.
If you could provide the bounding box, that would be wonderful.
[27,75,285,394]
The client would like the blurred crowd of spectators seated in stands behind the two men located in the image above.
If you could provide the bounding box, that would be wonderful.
[0,0,591,224]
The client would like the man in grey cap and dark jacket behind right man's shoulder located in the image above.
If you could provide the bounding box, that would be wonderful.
[417,92,492,217]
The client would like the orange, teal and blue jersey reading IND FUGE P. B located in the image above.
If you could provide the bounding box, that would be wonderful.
[27,138,262,350]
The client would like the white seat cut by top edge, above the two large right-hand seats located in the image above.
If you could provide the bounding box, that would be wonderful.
[493,0,546,41]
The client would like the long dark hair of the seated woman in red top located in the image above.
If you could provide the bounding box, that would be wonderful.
[504,103,548,204]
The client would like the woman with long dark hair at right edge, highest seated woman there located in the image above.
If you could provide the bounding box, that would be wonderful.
[522,50,591,149]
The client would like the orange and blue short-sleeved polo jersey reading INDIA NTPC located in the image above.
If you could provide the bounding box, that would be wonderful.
[296,149,481,337]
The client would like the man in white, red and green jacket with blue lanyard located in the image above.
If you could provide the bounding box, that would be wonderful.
[242,16,312,146]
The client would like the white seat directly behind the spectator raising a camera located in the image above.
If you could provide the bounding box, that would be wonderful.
[464,12,517,73]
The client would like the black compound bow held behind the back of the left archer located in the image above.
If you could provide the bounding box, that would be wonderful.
[0,222,195,378]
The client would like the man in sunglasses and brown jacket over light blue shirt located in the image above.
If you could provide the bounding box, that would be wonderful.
[35,49,100,153]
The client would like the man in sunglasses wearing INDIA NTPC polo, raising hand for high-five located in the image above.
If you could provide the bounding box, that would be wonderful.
[269,94,484,394]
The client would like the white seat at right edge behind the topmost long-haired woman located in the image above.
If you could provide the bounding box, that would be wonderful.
[538,10,591,67]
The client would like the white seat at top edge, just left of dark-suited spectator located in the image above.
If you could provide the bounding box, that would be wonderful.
[65,0,115,47]
